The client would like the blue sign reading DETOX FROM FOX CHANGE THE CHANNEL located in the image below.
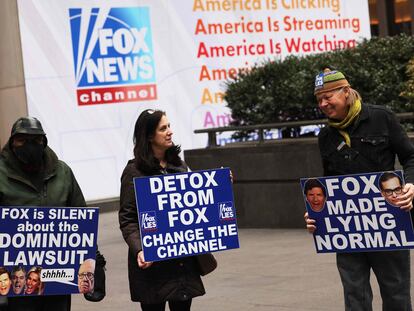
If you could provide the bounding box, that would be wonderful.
[134,169,239,261]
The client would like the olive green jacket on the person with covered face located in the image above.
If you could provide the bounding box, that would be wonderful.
[0,143,86,207]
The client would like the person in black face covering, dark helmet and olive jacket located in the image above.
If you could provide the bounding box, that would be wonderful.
[0,117,105,311]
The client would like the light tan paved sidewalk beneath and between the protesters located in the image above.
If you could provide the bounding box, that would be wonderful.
[72,212,408,311]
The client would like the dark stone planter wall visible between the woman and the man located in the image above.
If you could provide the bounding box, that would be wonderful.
[184,138,322,228]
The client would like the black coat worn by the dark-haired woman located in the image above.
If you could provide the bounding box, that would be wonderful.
[119,160,205,304]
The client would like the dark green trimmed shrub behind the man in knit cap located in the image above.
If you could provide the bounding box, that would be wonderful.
[225,34,414,132]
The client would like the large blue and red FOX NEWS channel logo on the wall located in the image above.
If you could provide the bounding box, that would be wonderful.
[69,7,157,105]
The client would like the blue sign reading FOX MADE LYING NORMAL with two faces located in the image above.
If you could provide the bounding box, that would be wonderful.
[300,171,414,253]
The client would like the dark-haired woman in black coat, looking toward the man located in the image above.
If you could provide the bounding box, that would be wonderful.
[119,109,205,311]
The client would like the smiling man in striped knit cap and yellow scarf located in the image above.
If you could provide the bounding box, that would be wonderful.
[305,69,414,311]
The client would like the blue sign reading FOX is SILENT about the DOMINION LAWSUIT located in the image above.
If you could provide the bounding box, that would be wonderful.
[0,206,99,296]
